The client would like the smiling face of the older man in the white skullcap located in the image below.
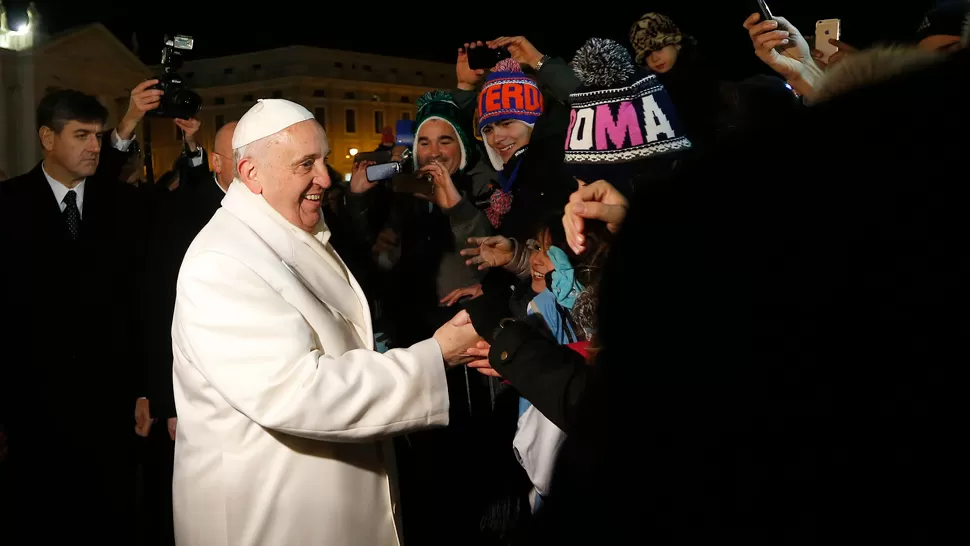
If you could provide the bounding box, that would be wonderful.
[238,120,330,232]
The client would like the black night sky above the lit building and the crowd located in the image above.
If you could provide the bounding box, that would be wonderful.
[4,0,935,79]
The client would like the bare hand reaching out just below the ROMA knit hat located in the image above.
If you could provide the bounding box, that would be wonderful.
[562,180,630,254]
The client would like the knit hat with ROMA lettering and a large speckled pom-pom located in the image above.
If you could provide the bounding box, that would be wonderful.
[565,38,691,185]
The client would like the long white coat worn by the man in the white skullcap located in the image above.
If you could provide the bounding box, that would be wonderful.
[172,180,448,546]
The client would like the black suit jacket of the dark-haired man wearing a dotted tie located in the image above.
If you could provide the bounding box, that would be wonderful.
[0,141,150,536]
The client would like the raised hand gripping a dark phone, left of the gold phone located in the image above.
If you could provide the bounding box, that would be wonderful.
[744,13,817,80]
